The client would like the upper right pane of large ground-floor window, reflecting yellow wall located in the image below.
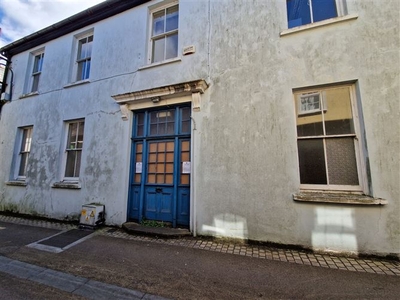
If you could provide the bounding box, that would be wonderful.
[324,87,354,135]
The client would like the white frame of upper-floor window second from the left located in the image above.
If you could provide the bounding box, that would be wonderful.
[70,29,94,83]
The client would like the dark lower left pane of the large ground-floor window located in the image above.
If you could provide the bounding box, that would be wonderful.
[297,139,327,184]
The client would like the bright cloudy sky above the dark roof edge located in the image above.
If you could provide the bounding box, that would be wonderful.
[0,0,104,47]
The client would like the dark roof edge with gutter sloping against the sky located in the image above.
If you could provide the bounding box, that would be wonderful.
[0,0,150,58]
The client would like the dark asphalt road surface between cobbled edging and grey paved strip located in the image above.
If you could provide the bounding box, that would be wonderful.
[0,222,400,299]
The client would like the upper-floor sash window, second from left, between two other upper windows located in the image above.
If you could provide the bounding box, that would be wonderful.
[76,35,93,81]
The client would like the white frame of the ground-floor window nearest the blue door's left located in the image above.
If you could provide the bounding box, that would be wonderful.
[62,119,85,183]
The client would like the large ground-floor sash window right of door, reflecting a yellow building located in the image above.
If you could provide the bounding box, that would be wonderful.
[294,85,365,191]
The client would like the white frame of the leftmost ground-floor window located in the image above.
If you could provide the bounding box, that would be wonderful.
[13,126,33,181]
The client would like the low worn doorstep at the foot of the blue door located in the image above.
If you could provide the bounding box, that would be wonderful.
[122,222,192,238]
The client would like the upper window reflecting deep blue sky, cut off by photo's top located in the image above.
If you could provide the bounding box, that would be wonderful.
[286,0,344,28]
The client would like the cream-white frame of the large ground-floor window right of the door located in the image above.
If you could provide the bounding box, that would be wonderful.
[293,84,369,194]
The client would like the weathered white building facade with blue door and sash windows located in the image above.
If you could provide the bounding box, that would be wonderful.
[0,0,400,257]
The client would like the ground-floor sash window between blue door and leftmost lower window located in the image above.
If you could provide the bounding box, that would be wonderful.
[64,120,85,180]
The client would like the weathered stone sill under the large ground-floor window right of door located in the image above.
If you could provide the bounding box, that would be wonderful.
[293,192,388,205]
